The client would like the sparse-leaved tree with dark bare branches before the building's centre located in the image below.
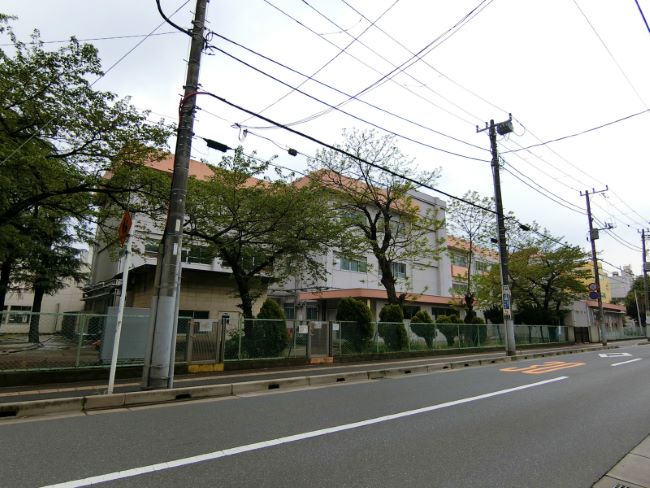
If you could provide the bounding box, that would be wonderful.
[310,130,443,305]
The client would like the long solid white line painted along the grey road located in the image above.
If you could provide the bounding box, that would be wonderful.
[42,376,568,488]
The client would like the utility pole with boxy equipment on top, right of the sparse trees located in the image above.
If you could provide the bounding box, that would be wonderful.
[476,114,517,356]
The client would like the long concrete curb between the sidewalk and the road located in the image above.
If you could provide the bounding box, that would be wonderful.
[0,345,617,422]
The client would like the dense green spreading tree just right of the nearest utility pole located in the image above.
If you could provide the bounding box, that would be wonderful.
[185,148,345,350]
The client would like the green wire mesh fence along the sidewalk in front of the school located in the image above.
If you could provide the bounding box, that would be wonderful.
[0,309,632,371]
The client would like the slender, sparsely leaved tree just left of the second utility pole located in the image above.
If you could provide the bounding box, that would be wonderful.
[446,191,496,324]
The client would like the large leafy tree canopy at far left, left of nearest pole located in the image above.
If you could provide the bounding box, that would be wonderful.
[0,15,172,308]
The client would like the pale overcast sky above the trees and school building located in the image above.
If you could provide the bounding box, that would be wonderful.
[2,0,650,274]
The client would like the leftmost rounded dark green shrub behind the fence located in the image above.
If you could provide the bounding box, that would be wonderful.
[247,298,289,357]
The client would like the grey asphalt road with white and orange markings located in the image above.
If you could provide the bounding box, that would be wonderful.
[0,346,650,488]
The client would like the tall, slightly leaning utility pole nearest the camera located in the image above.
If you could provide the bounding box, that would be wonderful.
[142,0,208,389]
